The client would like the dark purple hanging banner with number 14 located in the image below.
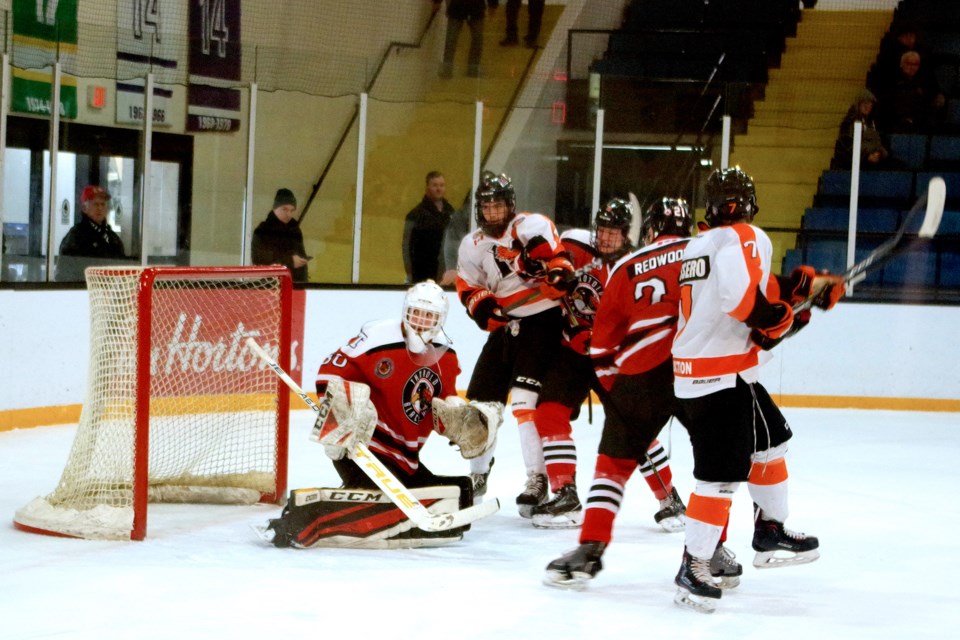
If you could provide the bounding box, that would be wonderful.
[187,0,240,131]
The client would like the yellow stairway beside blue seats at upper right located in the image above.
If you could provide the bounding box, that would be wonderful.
[730,9,893,270]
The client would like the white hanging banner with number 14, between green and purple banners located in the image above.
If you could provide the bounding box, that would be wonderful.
[117,0,187,127]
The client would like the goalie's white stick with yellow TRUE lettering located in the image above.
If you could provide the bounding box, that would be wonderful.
[246,338,500,531]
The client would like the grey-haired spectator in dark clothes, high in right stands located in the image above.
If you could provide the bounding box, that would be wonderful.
[877,51,946,133]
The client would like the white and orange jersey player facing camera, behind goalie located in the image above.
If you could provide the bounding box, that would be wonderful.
[457,171,573,518]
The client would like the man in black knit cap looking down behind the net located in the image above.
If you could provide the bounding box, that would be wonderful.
[251,189,310,282]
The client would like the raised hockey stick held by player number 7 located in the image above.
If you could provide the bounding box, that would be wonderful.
[793,176,947,313]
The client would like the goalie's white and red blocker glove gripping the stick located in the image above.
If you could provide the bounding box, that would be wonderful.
[310,378,377,460]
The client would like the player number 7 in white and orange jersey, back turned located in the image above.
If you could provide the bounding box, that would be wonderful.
[673,167,843,612]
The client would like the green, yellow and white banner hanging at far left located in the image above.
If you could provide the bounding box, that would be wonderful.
[10,0,78,118]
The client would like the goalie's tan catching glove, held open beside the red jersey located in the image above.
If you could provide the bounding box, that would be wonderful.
[432,396,503,460]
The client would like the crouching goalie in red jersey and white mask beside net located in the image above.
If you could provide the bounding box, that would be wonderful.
[264,281,503,549]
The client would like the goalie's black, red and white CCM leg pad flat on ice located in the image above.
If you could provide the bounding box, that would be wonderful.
[267,486,464,549]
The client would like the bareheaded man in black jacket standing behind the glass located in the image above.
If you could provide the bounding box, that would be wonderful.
[403,171,456,283]
